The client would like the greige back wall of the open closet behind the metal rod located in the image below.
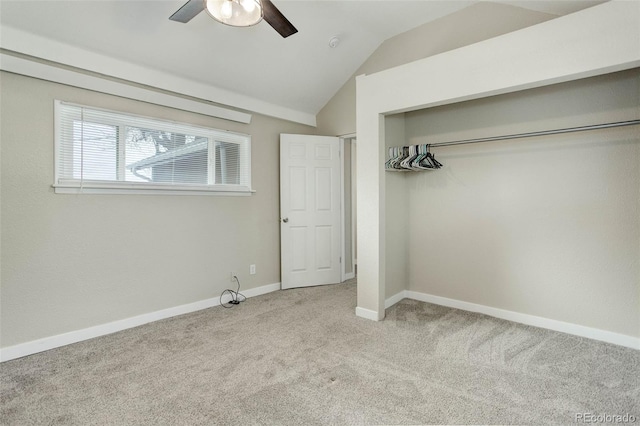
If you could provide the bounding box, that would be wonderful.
[408,69,640,337]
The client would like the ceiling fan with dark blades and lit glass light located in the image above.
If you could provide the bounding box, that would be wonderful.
[169,0,298,37]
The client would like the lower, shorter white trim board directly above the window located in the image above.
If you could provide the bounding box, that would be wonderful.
[0,53,251,124]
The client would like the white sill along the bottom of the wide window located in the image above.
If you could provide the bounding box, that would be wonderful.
[52,182,256,197]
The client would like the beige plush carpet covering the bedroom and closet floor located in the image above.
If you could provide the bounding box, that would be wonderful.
[0,281,640,425]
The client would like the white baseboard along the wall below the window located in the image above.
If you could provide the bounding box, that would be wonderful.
[0,283,280,362]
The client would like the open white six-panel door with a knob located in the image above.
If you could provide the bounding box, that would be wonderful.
[280,134,342,289]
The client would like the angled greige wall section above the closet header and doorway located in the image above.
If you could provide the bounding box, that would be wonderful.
[317,2,555,135]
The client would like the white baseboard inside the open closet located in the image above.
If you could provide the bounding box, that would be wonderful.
[385,290,640,349]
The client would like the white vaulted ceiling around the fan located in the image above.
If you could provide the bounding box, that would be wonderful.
[0,0,601,124]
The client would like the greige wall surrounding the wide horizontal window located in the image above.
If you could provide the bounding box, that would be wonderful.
[0,72,315,347]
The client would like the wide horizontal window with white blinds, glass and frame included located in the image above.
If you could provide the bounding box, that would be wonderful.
[54,101,251,193]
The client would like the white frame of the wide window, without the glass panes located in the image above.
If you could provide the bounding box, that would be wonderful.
[52,100,255,196]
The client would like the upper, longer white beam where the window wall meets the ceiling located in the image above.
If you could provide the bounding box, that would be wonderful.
[0,25,316,127]
